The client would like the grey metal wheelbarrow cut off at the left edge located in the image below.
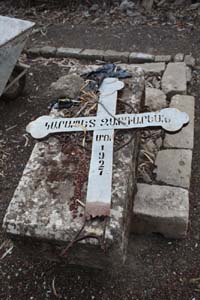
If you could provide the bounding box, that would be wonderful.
[0,16,35,99]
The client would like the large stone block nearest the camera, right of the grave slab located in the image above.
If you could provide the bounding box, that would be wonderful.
[131,184,189,238]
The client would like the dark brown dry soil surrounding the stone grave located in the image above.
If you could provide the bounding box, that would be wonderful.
[0,1,200,300]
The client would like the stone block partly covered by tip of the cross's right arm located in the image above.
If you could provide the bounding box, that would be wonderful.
[164,95,195,149]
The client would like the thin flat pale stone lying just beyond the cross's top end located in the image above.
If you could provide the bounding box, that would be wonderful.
[120,63,165,75]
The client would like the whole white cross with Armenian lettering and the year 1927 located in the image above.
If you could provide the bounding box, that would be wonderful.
[26,78,189,217]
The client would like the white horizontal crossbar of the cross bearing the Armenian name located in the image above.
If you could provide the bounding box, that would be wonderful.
[26,108,189,139]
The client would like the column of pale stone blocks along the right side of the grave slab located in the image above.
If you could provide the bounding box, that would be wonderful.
[132,61,195,238]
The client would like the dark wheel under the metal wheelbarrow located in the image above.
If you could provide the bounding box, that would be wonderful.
[2,65,26,100]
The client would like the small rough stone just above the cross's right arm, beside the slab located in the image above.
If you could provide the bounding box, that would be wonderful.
[145,87,167,111]
